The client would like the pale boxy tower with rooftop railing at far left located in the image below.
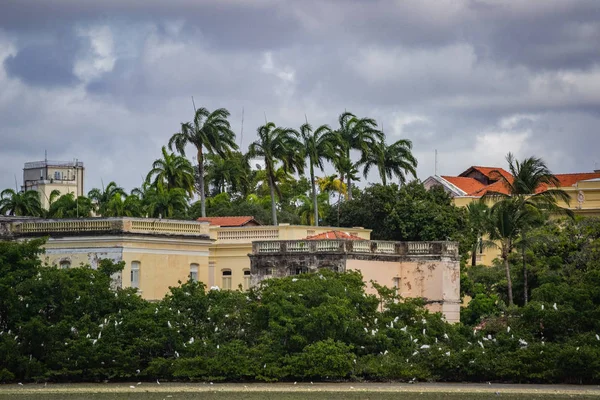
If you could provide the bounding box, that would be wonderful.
[21,160,85,209]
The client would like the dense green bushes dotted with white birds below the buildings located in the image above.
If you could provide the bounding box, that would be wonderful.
[0,219,600,383]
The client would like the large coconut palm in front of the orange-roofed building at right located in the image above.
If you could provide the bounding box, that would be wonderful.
[483,153,573,305]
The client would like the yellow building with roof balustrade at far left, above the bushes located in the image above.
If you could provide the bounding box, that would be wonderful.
[0,218,212,300]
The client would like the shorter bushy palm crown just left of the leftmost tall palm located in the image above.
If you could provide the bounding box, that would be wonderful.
[146,146,194,196]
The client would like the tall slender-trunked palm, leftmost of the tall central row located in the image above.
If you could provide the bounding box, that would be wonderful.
[169,107,238,217]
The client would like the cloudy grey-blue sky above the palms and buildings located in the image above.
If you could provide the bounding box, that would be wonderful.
[0,0,600,194]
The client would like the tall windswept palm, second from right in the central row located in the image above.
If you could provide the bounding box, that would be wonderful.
[335,112,384,200]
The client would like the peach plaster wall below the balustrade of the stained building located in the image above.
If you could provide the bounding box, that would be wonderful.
[346,258,460,322]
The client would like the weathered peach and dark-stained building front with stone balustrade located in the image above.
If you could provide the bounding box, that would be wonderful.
[250,237,461,322]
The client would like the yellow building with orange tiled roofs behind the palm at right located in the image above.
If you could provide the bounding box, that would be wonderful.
[423,166,600,265]
